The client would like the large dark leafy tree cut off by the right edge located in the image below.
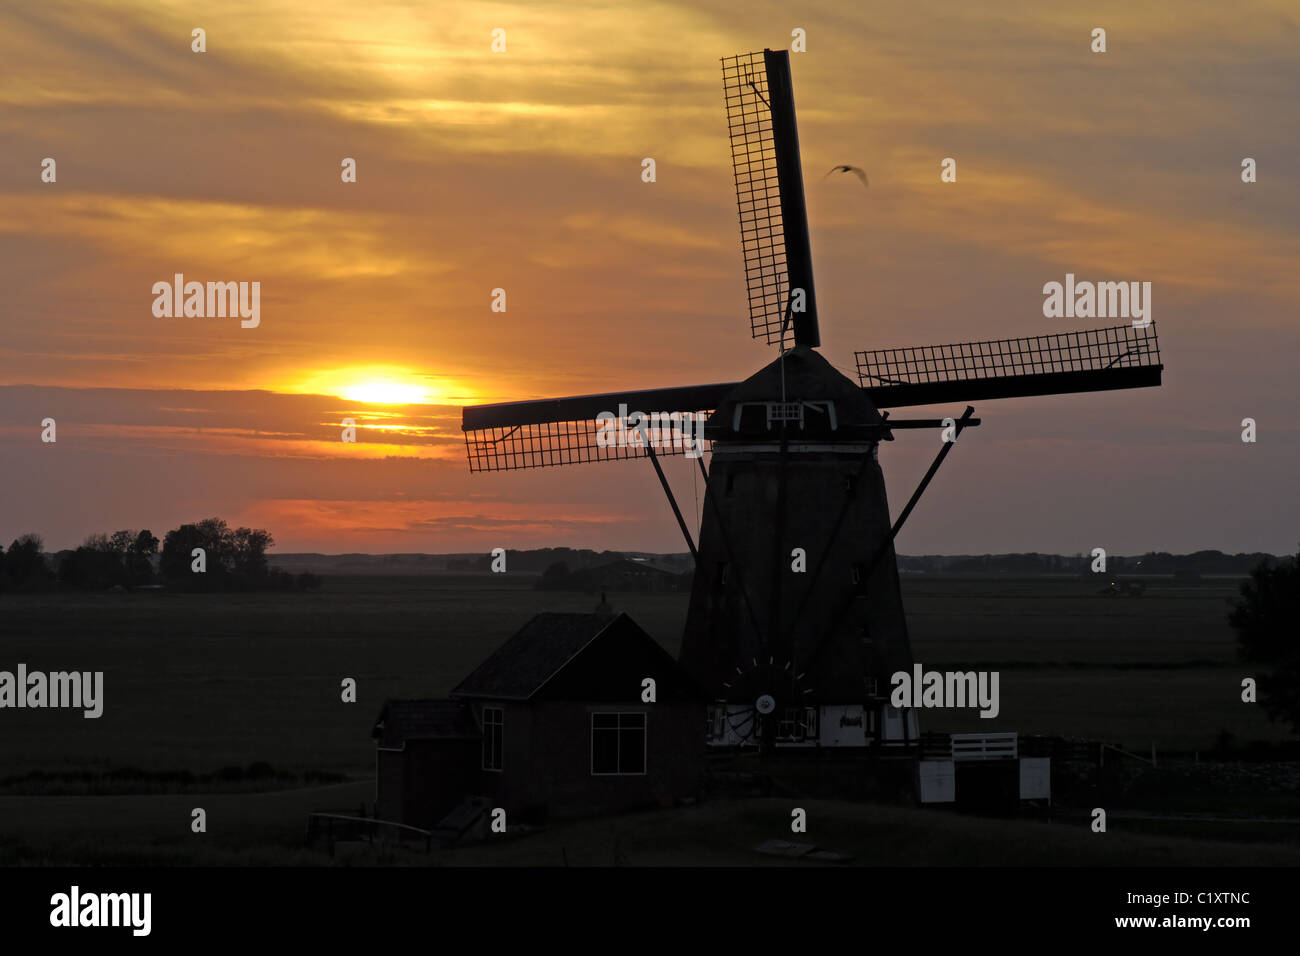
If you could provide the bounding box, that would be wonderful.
[1227,553,1300,732]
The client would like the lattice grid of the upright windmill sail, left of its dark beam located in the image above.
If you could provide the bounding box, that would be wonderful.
[722,52,788,345]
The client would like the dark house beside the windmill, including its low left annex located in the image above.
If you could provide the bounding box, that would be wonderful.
[376,614,706,826]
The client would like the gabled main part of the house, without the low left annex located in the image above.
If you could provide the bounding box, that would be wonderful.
[451,614,706,821]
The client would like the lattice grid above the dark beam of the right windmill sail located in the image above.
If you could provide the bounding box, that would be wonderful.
[854,323,1160,388]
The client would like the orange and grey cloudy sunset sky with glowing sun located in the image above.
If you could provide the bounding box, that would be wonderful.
[0,0,1300,554]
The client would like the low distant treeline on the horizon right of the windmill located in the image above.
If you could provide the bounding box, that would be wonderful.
[898,551,1277,578]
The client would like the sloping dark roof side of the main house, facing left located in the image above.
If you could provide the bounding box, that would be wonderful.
[451,613,624,700]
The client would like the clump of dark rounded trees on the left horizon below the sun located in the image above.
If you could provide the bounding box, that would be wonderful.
[0,518,320,591]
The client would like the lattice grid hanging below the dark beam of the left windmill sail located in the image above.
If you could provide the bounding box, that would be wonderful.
[465,408,712,472]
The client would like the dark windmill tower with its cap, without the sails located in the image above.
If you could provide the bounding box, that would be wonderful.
[681,346,915,747]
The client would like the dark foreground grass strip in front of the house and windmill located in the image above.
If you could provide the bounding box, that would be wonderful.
[0,783,1300,866]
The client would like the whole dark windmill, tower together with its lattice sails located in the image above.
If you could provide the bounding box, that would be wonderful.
[462,49,1164,749]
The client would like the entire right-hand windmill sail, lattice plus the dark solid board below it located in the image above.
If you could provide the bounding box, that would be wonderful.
[854,323,1165,408]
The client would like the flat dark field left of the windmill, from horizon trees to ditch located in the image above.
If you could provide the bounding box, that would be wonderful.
[0,578,685,778]
